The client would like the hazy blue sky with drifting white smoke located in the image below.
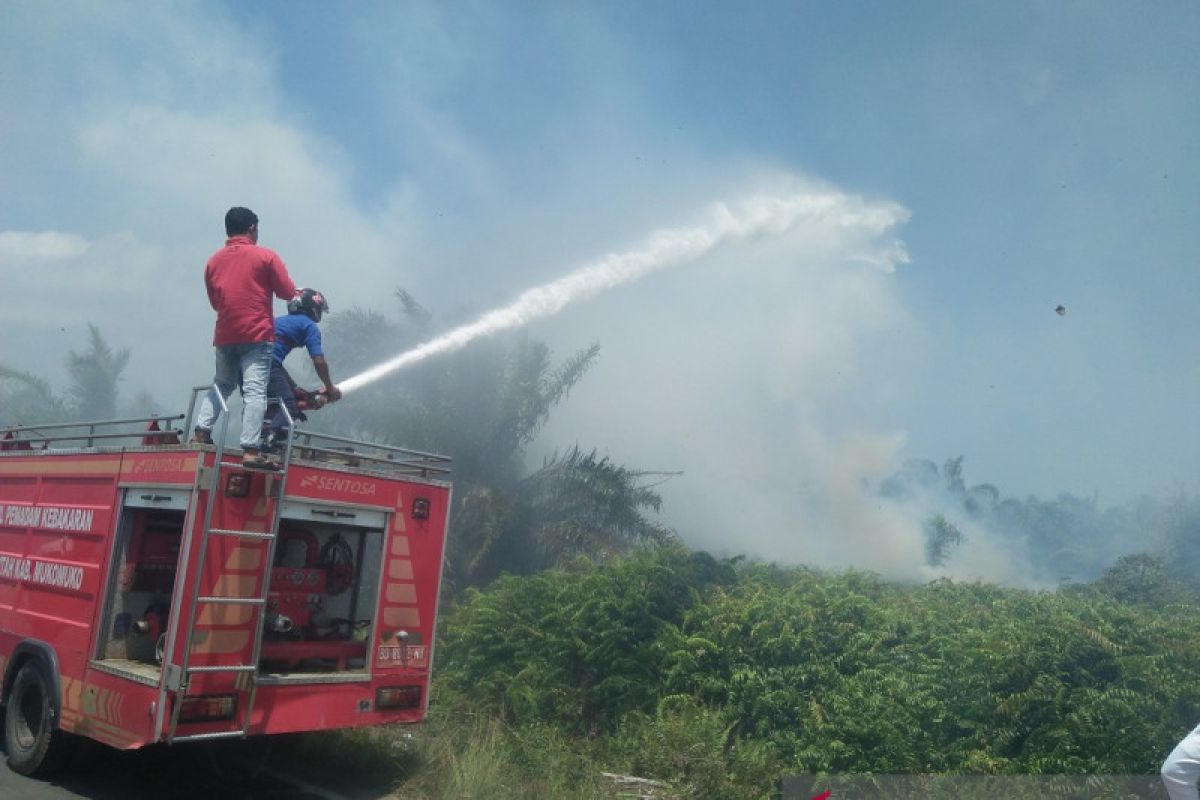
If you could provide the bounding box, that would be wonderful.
[0,0,1200,575]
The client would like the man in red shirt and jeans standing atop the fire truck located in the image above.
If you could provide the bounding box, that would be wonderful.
[196,206,296,469]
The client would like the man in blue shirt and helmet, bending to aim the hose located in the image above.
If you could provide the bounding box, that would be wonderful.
[264,289,342,445]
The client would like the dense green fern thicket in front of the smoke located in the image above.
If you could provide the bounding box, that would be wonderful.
[420,547,1200,798]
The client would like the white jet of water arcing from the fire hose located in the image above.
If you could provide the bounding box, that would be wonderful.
[338,194,894,395]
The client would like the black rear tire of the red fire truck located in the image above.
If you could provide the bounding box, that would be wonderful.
[4,661,67,776]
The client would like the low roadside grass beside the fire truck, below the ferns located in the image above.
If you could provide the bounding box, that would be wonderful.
[291,700,776,800]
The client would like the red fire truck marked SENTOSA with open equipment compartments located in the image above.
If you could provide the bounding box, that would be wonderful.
[0,392,450,775]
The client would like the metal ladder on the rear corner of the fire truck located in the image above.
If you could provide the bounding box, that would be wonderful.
[160,386,295,744]
